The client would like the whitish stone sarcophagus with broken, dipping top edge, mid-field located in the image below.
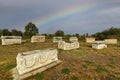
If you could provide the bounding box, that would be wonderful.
[58,41,79,50]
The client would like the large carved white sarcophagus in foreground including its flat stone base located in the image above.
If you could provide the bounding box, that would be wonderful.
[13,49,61,80]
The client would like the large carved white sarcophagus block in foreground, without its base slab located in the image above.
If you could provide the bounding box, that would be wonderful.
[16,49,58,75]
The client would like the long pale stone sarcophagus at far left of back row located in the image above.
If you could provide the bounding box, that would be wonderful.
[1,36,22,45]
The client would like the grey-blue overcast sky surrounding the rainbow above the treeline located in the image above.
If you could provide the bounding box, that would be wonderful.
[0,0,120,34]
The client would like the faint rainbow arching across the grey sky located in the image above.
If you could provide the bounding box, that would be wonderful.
[33,5,95,27]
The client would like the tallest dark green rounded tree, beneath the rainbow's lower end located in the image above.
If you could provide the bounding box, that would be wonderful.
[24,22,38,37]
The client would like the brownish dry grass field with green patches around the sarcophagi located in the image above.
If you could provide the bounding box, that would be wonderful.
[0,41,120,80]
